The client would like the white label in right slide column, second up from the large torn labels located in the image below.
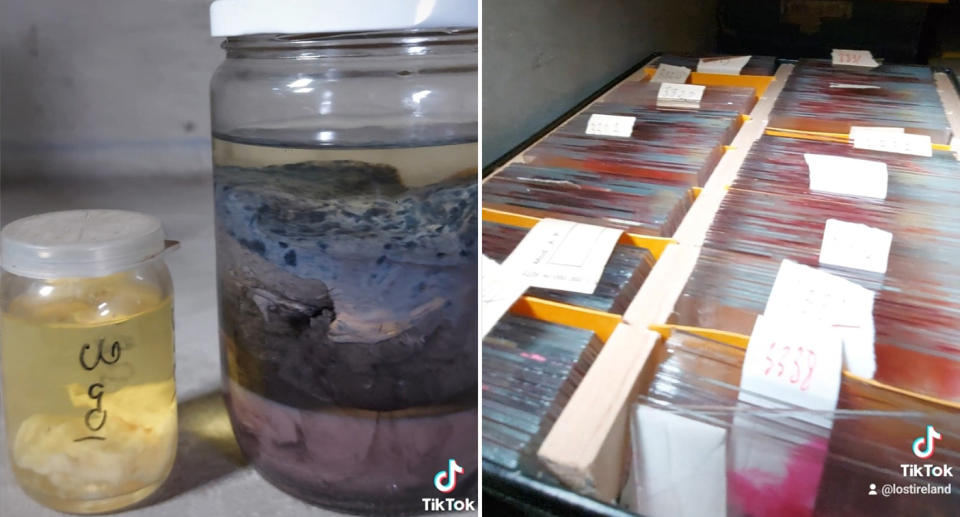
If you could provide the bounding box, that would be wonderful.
[803,153,889,199]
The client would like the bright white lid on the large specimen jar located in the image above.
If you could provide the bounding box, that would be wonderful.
[210,0,478,37]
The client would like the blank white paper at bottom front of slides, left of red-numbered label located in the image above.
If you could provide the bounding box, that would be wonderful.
[627,405,727,517]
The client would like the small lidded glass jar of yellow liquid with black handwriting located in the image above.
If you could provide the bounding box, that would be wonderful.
[0,210,177,513]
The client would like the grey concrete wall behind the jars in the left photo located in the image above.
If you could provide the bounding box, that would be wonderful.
[0,0,222,183]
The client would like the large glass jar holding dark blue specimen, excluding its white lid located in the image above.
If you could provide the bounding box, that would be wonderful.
[211,2,478,512]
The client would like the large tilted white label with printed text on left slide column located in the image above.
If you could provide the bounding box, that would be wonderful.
[503,219,623,294]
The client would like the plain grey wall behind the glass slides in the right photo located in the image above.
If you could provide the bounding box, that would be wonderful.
[482,0,716,164]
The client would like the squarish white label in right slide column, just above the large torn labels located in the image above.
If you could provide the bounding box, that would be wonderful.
[820,219,893,274]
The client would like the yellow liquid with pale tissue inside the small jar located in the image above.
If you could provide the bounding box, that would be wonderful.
[0,275,177,513]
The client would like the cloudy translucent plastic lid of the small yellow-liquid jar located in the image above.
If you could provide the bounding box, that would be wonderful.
[0,210,165,278]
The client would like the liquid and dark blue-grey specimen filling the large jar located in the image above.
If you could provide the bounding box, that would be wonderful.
[214,139,477,513]
